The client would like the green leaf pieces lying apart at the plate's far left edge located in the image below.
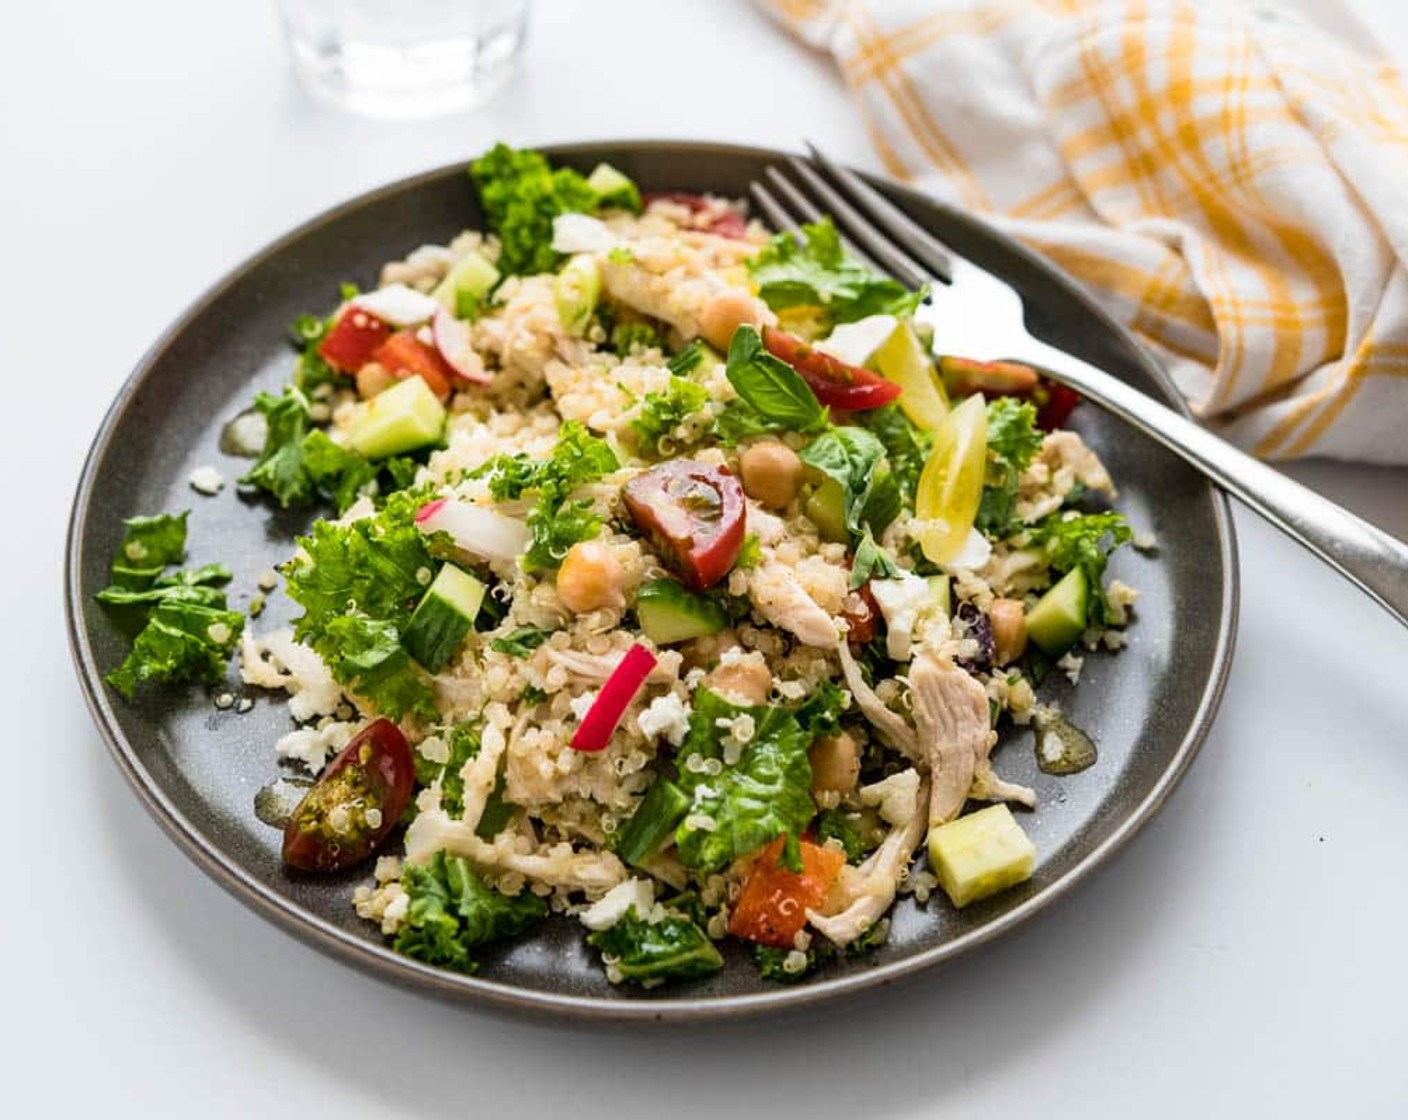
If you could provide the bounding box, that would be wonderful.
[97,511,245,699]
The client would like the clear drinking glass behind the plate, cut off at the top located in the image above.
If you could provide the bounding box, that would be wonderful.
[279,0,528,117]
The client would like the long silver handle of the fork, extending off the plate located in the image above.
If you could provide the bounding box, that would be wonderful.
[1012,338,1408,626]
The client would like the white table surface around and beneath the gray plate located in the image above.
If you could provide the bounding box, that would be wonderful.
[0,0,1408,1117]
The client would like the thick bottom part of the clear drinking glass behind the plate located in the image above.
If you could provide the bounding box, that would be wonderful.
[289,18,524,117]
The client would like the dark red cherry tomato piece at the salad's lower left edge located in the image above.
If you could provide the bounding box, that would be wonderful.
[283,720,415,871]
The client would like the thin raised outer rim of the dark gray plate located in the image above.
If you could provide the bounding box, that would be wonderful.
[63,138,1240,1023]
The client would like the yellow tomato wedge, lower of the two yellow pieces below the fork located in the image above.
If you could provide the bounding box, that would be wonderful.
[914,393,987,564]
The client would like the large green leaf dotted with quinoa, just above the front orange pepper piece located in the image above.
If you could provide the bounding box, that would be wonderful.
[674,685,843,872]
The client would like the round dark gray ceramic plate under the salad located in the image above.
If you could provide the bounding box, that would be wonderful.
[66,142,1236,1019]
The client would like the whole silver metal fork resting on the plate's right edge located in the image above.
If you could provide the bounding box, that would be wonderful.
[752,145,1408,626]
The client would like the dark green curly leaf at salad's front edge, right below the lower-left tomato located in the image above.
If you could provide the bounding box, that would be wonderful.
[394,852,548,972]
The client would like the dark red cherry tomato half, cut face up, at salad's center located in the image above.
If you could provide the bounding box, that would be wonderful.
[621,459,745,592]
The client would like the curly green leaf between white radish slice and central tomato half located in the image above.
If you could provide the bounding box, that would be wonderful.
[473,420,621,572]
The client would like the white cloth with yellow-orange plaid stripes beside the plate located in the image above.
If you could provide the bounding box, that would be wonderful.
[763,0,1408,463]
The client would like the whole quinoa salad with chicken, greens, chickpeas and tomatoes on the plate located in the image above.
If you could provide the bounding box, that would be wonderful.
[104,145,1135,986]
